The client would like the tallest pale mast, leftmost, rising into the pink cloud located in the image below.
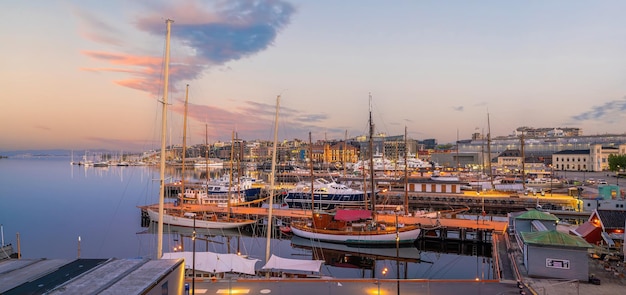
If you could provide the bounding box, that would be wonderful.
[156,19,174,259]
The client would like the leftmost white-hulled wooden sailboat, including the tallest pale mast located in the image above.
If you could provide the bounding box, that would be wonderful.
[139,26,256,234]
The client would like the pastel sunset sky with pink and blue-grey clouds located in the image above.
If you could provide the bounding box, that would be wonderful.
[0,0,626,152]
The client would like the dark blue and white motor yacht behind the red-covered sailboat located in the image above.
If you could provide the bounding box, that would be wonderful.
[284,178,366,210]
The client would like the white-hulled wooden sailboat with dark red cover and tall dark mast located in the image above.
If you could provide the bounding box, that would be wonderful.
[290,94,421,246]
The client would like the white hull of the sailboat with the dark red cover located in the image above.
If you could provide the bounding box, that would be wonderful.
[291,225,421,245]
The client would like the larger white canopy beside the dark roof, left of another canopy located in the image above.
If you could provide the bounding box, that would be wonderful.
[162,252,259,275]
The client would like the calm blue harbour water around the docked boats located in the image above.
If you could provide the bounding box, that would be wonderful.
[0,157,493,279]
